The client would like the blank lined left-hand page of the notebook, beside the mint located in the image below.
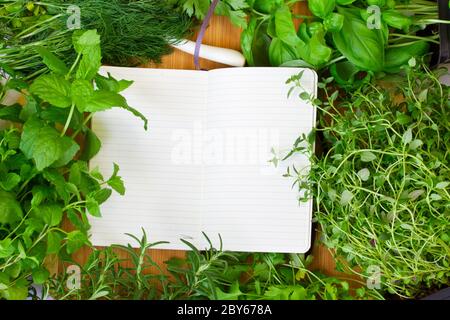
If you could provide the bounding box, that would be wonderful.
[90,67,208,249]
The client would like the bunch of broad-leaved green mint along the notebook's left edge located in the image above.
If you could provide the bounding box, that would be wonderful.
[0,30,147,299]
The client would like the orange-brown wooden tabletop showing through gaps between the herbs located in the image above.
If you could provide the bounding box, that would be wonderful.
[70,6,358,284]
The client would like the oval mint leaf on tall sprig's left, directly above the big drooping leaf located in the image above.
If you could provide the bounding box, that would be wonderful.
[30,74,72,108]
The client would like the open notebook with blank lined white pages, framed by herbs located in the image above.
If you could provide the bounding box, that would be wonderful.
[90,67,317,253]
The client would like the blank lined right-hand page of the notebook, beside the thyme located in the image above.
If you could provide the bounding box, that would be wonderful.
[203,68,317,252]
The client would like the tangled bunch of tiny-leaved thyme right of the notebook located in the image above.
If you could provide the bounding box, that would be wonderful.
[288,59,450,297]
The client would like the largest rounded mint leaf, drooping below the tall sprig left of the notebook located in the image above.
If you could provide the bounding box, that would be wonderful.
[20,118,67,171]
